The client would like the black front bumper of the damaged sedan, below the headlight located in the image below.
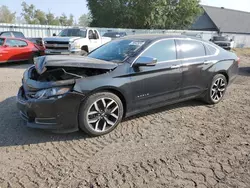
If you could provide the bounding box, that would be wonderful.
[17,87,84,132]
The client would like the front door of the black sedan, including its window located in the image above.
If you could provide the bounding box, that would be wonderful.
[130,39,182,110]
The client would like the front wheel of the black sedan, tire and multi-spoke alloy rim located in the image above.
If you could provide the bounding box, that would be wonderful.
[79,92,123,136]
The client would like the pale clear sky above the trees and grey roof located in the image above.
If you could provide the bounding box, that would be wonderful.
[0,0,250,18]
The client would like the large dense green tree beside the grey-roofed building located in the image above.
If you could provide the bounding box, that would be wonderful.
[87,0,202,29]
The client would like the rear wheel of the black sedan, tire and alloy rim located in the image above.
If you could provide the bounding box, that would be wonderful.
[203,74,228,104]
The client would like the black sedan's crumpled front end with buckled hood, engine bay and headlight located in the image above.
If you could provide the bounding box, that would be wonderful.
[23,56,118,94]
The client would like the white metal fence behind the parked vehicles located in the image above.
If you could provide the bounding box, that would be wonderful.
[0,23,250,47]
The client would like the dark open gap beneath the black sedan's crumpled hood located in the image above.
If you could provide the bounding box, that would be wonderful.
[31,67,109,82]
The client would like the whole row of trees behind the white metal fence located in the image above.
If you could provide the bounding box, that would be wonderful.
[0,0,202,29]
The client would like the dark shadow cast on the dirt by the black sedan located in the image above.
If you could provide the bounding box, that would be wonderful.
[0,97,207,147]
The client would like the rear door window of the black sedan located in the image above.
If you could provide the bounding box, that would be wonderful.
[180,40,206,58]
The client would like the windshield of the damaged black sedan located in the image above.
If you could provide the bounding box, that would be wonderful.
[88,40,145,62]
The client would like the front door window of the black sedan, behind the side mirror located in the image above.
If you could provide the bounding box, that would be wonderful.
[141,40,176,62]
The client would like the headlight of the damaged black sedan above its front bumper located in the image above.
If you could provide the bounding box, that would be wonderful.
[34,87,71,99]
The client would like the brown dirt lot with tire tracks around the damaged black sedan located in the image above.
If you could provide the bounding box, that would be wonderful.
[0,53,250,188]
